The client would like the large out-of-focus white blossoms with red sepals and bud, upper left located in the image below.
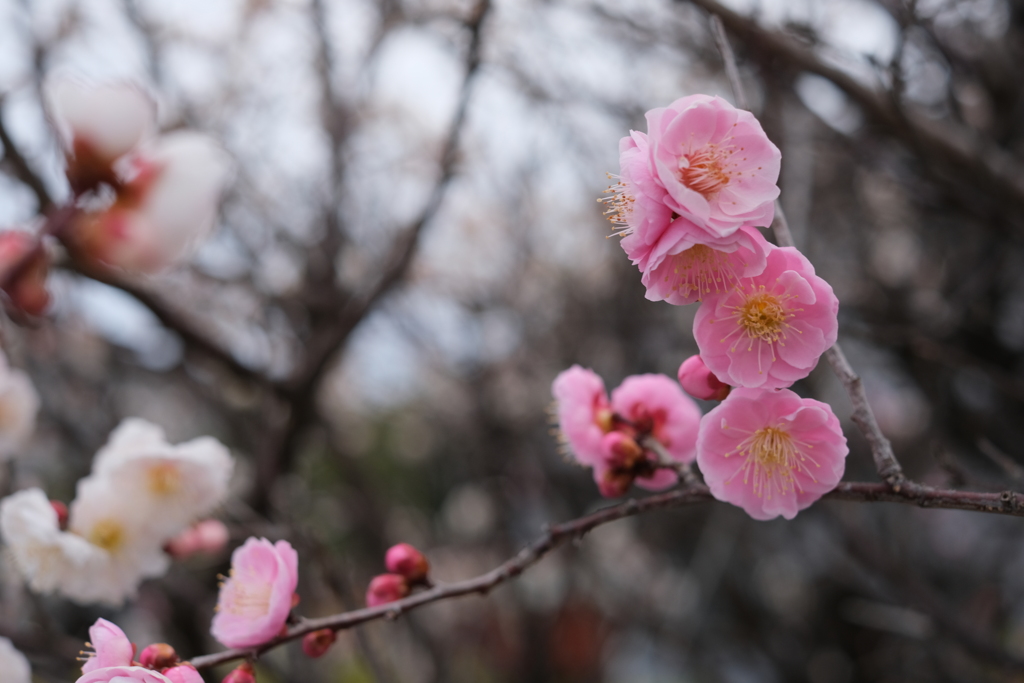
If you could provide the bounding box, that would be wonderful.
[0,79,231,315]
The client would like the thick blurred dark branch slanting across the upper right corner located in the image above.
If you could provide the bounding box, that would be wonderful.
[688,0,1024,222]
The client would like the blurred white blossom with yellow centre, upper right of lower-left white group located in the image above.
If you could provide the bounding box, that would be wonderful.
[90,418,233,539]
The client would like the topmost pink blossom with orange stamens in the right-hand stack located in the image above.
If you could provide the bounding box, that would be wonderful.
[647,95,781,237]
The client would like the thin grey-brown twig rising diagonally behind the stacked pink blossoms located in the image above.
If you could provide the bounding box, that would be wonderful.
[698,13,921,493]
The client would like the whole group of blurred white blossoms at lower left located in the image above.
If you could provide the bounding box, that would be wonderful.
[0,418,233,605]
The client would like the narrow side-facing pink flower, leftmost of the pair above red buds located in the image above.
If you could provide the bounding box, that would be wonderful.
[551,366,612,466]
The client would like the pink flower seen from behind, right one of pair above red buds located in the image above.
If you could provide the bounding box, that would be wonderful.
[611,375,700,490]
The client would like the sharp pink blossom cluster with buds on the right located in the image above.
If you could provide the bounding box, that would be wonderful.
[553,95,848,519]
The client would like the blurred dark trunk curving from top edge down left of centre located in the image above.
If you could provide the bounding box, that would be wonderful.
[253,0,490,509]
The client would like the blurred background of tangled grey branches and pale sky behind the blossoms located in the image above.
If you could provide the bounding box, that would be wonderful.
[0,0,1024,683]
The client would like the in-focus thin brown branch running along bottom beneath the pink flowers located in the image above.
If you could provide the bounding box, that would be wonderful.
[191,482,1024,669]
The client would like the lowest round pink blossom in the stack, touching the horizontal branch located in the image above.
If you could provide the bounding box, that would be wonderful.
[697,388,849,519]
